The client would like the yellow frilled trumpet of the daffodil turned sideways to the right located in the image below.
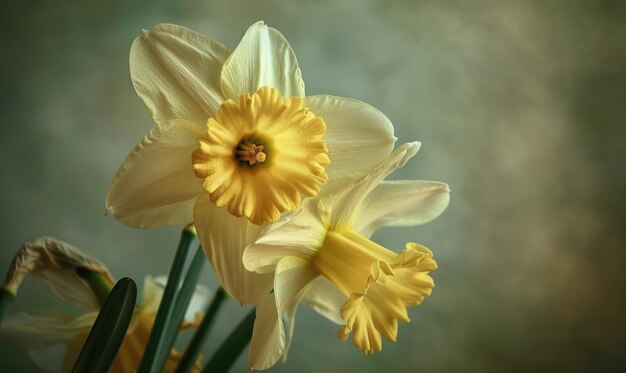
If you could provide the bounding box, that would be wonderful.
[312,229,437,354]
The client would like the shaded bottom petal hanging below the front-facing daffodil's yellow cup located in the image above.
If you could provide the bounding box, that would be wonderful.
[194,193,273,304]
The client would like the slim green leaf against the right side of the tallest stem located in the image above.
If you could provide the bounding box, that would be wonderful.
[155,246,207,370]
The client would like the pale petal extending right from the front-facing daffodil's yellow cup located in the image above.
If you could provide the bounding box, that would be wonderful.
[304,95,396,195]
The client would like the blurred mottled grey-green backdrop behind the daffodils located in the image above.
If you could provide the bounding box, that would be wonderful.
[0,0,626,373]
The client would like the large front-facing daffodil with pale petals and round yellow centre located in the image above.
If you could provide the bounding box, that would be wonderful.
[106,22,395,304]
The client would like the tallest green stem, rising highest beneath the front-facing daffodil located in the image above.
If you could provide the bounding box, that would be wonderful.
[138,227,196,373]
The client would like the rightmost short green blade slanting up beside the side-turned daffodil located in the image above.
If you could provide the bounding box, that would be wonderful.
[202,310,256,373]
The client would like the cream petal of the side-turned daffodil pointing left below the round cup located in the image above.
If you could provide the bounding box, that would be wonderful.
[243,201,326,273]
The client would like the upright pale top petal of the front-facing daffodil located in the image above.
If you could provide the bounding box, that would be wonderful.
[221,22,304,100]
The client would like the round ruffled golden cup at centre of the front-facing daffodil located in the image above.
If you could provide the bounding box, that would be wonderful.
[192,87,330,225]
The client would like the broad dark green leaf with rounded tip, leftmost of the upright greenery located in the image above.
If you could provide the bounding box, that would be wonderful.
[72,277,137,373]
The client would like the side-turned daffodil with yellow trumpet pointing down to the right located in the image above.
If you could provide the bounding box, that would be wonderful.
[243,143,449,369]
